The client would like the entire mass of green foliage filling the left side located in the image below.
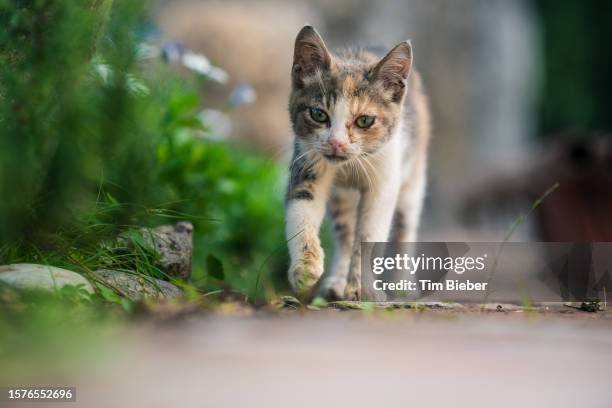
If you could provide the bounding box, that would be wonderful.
[0,0,286,296]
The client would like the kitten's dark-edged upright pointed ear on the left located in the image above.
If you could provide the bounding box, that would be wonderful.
[291,25,331,87]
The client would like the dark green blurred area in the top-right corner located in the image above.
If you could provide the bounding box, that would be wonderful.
[535,0,612,134]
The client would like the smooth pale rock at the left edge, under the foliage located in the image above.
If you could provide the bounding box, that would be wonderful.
[0,264,94,293]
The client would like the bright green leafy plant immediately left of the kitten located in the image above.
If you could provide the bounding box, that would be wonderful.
[157,92,286,295]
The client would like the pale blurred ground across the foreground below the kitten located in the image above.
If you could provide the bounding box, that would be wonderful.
[14,307,612,408]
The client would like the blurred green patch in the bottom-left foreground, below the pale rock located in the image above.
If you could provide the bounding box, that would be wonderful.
[0,285,125,384]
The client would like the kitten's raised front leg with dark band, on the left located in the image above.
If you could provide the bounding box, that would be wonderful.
[286,153,334,295]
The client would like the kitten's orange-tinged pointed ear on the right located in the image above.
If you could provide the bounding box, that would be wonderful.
[371,41,412,102]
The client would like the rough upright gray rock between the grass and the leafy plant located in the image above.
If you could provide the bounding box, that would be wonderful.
[119,221,193,279]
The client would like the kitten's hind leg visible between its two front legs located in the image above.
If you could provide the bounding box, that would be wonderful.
[318,188,359,301]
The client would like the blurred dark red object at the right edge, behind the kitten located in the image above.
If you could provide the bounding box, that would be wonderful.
[465,135,612,241]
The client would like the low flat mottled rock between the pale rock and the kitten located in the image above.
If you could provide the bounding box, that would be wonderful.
[95,269,183,300]
